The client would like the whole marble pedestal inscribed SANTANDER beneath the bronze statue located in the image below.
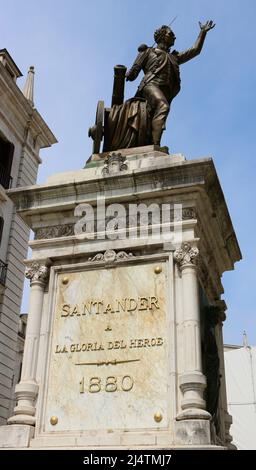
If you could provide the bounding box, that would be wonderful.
[0,146,241,449]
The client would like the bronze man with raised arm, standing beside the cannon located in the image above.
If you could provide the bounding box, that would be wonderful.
[126,21,215,145]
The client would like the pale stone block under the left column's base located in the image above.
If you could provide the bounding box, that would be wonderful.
[0,424,35,449]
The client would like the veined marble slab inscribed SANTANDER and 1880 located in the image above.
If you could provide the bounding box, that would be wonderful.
[45,262,168,432]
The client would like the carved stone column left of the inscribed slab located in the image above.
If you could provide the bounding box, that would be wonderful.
[8,262,49,425]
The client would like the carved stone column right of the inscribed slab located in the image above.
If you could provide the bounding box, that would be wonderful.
[174,243,211,421]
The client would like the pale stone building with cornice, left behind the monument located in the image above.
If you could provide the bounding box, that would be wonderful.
[0,49,56,425]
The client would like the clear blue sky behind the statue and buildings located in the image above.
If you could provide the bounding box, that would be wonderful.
[0,0,256,344]
